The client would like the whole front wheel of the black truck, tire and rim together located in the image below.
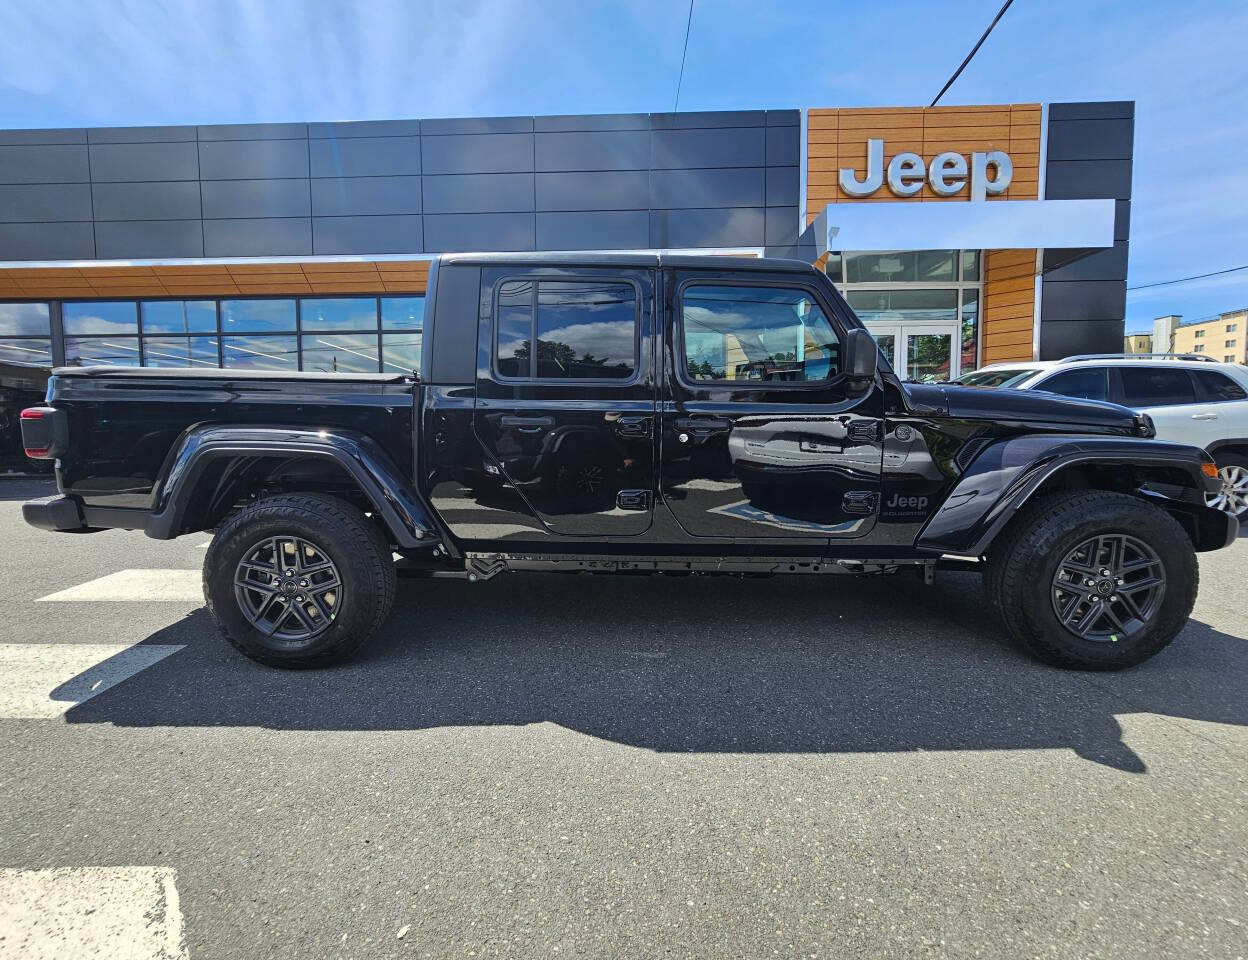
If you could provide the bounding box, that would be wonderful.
[985,491,1199,670]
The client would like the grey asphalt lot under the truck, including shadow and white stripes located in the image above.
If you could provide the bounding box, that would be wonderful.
[0,481,1248,960]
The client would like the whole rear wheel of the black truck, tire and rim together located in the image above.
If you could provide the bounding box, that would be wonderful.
[203,493,396,668]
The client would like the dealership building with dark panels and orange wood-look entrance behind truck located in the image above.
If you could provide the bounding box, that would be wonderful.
[0,102,1134,458]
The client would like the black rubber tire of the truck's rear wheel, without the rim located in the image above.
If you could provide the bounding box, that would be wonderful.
[203,493,396,669]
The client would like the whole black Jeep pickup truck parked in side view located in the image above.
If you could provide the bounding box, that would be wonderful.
[21,253,1238,669]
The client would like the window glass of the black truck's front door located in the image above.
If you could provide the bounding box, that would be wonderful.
[680,285,841,382]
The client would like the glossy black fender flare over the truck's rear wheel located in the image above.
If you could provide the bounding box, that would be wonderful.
[144,424,441,548]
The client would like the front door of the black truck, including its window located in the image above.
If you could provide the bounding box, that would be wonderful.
[660,271,884,543]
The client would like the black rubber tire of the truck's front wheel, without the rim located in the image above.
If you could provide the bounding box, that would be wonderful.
[983,491,1199,670]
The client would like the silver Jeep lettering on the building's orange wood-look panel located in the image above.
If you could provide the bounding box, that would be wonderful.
[840,140,1013,200]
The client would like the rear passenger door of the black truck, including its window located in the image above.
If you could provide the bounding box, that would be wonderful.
[473,267,655,537]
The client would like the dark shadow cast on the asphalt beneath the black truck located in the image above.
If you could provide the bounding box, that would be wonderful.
[66,574,1248,773]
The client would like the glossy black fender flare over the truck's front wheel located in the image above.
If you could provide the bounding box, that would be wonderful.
[915,434,1234,557]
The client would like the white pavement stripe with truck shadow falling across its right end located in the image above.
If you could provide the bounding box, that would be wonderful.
[0,643,182,719]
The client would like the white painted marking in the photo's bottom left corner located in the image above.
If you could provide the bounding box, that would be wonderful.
[0,866,187,960]
